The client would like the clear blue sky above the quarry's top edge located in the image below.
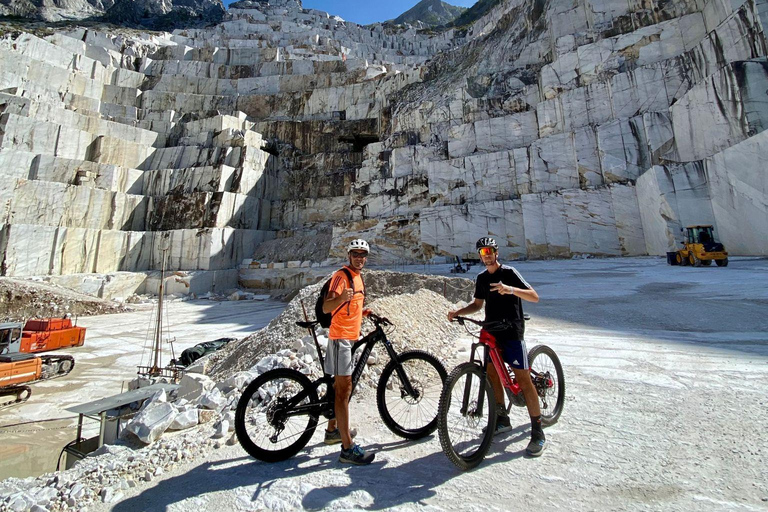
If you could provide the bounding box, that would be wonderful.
[224,0,477,25]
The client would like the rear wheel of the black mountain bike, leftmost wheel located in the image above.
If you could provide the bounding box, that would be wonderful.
[235,368,318,462]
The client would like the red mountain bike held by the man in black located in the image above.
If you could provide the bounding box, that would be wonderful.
[438,315,565,470]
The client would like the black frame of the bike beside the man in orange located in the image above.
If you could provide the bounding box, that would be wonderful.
[282,322,418,424]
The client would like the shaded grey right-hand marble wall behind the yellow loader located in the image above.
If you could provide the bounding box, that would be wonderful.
[340,1,768,259]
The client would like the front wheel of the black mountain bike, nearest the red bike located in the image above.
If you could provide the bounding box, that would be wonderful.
[376,350,448,439]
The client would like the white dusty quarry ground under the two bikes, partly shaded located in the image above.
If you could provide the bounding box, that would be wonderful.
[0,258,768,511]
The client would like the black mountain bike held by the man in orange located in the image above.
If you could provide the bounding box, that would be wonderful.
[235,314,447,462]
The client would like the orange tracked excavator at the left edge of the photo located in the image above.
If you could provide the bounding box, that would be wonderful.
[0,318,85,409]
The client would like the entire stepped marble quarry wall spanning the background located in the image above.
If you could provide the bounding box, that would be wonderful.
[0,0,768,292]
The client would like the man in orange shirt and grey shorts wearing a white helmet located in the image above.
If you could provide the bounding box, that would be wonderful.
[323,239,375,465]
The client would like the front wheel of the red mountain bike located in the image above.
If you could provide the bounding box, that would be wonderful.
[437,363,496,470]
